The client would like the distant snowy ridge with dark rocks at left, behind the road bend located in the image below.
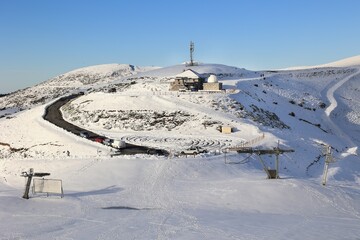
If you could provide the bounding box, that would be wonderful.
[0,64,157,116]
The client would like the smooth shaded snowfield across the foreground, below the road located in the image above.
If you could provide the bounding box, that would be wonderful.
[0,156,360,239]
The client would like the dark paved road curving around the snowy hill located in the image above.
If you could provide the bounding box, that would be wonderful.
[44,93,168,155]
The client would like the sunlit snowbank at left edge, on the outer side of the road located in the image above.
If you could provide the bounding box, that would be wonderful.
[0,103,104,159]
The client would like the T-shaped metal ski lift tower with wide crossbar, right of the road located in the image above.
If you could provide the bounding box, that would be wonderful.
[225,143,295,179]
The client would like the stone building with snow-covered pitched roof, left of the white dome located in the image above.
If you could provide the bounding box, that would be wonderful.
[170,69,205,91]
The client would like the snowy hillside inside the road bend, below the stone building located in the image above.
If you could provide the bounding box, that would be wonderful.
[59,65,359,179]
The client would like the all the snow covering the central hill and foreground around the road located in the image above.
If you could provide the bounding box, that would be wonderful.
[0,57,360,239]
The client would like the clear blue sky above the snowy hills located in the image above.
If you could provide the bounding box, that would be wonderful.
[0,0,360,93]
